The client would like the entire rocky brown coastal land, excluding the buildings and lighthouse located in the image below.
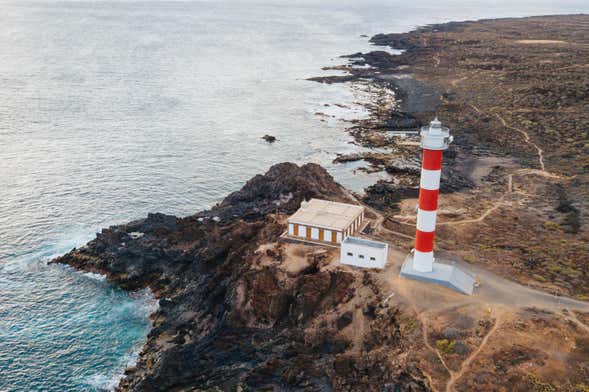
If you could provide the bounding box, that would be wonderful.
[52,15,589,392]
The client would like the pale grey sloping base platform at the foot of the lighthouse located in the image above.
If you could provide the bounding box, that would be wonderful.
[400,254,475,295]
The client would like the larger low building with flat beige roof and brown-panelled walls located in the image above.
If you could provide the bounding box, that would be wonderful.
[287,199,364,244]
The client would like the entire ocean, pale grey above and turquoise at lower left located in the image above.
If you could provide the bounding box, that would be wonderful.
[0,0,589,391]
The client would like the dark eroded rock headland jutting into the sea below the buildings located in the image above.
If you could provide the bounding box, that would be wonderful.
[54,163,426,391]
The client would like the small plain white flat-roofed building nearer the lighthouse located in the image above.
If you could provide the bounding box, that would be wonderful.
[340,237,389,269]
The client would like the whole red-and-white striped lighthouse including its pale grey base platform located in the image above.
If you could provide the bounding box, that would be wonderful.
[401,118,475,295]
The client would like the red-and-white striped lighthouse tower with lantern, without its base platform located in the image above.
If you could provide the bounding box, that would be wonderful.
[413,118,452,272]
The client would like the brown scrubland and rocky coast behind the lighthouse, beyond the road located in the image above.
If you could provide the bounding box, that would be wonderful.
[312,15,589,298]
